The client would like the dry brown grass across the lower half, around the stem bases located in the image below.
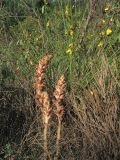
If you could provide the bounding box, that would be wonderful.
[0,56,120,160]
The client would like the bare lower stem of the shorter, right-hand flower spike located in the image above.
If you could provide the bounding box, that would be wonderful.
[55,117,61,160]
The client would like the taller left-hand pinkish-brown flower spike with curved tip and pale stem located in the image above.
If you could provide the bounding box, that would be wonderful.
[35,55,52,160]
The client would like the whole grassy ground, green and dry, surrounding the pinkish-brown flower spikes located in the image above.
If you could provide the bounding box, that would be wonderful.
[0,0,120,160]
